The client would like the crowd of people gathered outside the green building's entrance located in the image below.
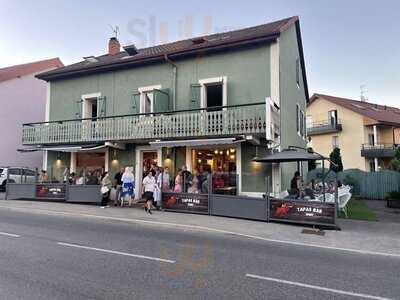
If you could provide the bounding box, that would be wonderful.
[39,162,234,214]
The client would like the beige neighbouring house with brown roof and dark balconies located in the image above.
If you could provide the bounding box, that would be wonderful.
[306,94,400,171]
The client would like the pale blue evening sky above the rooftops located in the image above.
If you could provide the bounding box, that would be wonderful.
[0,0,400,107]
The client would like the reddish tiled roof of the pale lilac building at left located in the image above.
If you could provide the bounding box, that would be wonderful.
[0,57,64,82]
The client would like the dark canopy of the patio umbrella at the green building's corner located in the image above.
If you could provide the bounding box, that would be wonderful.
[253,149,327,163]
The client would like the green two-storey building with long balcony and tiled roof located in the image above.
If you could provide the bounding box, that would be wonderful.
[23,17,308,196]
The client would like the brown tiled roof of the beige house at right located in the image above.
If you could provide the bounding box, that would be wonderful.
[308,94,400,125]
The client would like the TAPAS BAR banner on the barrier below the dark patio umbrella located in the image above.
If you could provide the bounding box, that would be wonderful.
[269,199,335,224]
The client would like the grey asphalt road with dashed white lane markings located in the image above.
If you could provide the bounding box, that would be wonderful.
[0,209,400,300]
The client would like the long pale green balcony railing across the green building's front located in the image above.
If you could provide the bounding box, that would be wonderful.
[22,102,266,145]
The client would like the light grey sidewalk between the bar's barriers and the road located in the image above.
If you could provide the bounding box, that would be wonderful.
[0,200,400,258]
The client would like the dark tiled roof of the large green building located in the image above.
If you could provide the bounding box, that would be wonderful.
[37,17,298,80]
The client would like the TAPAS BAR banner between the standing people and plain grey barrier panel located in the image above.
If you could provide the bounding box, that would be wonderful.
[162,193,208,214]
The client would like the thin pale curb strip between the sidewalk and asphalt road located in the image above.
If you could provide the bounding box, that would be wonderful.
[0,205,400,258]
